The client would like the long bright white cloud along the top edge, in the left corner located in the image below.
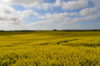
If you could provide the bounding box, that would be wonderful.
[0,0,43,8]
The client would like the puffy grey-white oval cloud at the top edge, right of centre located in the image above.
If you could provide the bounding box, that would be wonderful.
[62,0,88,10]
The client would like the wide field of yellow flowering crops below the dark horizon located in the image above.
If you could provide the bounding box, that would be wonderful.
[0,31,100,66]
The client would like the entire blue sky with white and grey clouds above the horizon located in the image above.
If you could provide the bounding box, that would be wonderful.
[0,0,100,30]
